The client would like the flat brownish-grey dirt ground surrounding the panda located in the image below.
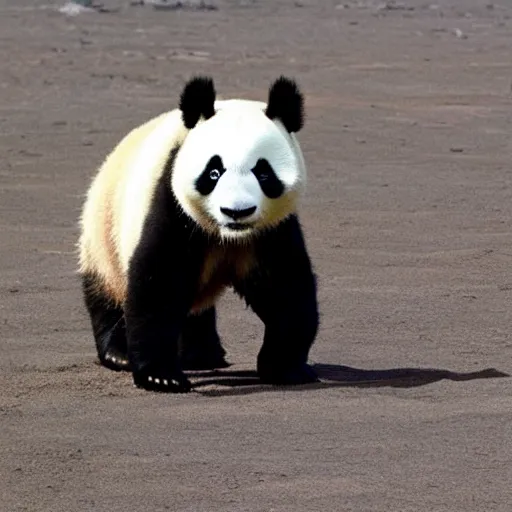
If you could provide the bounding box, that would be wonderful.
[0,0,512,512]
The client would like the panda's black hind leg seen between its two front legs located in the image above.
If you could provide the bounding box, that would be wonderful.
[179,307,230,370]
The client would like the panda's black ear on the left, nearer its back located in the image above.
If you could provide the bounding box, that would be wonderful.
[180,76,215,130]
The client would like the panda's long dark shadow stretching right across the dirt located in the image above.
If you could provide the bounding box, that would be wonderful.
[189,363,510,396]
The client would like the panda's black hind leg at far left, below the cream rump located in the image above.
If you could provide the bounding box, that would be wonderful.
[82,274,130,371]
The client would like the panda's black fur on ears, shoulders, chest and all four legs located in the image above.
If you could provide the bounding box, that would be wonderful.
[82,77,318,392]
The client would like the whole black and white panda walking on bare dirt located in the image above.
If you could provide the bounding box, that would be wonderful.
[78,76,319,393]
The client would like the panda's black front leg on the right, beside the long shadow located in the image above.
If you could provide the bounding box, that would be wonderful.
[236,216,319,385]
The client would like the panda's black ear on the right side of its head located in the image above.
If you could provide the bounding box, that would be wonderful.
[265,76,304,133]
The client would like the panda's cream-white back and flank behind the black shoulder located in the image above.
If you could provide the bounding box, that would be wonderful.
[79,110,186,303]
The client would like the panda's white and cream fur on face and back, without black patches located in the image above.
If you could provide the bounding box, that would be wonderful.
[79,99,306,303]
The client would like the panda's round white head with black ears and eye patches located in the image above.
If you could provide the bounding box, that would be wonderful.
[172,77,306,240]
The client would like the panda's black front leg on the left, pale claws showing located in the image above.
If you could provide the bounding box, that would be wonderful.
[124,227,199,393]
